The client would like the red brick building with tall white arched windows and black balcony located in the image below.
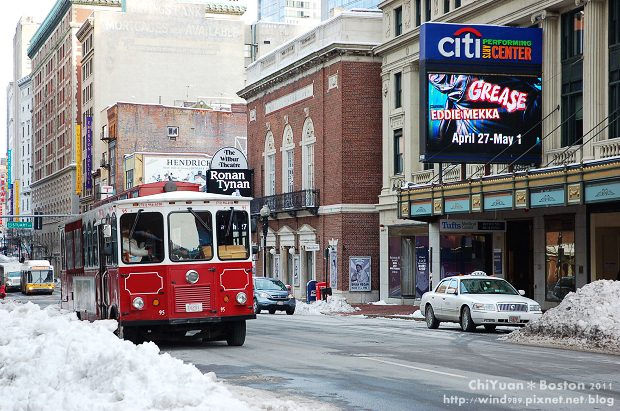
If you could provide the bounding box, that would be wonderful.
[239,12,381,301]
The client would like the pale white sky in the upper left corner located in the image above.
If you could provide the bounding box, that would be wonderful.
[0,0,56,157]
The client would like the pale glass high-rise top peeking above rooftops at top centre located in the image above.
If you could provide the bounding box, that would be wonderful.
[258,0,321,24]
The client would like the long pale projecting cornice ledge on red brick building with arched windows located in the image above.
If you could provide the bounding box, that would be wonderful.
[237,43,374,100]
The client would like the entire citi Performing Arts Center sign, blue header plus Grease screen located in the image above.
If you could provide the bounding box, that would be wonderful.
[420,23,543,164]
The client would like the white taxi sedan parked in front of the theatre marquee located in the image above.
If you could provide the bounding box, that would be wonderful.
[420,271,542,331]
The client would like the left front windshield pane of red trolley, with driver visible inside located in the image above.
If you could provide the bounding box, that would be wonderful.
[120,212,164,264]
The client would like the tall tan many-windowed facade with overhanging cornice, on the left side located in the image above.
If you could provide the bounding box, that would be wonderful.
[27,0,121,269]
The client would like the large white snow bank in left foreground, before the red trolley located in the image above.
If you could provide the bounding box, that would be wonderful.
[0,302,302,410]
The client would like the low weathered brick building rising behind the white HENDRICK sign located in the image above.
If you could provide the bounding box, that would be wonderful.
[101,103,247,193]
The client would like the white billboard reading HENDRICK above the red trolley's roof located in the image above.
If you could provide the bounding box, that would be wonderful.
[143,155,209,190]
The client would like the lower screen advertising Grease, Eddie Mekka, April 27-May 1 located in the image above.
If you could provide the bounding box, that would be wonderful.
[425,73,542,164]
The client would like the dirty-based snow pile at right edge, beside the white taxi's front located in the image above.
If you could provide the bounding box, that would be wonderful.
[503,280,620,353]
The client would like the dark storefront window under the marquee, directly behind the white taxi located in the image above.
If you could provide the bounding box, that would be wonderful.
[440,234,492,278]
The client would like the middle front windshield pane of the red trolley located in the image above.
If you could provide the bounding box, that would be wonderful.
[168,210,213,261]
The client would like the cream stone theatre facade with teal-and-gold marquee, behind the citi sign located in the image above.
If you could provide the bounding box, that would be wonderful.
[376,0,620,308]
